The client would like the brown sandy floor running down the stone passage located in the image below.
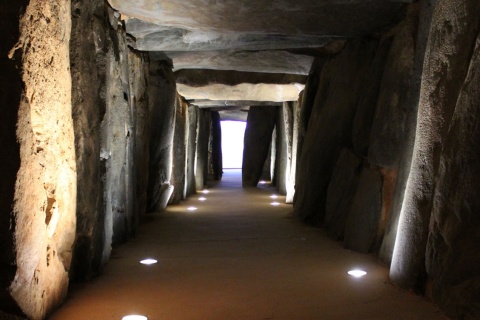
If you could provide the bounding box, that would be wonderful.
[50,170,446,320]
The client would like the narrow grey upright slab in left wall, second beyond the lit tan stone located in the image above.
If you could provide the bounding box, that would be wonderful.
[100,20,134,254]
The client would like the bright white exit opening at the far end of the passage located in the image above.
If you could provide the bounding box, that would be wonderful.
[220,121,247,169]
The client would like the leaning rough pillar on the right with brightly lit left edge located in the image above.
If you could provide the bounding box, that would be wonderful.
[390,0,480,291]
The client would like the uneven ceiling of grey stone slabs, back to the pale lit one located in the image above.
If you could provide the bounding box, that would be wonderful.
[109,0,411,117]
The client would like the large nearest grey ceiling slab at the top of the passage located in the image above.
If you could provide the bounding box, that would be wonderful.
[109,0,404,51]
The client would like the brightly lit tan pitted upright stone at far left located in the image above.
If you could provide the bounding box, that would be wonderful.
[8,0,77,319]
